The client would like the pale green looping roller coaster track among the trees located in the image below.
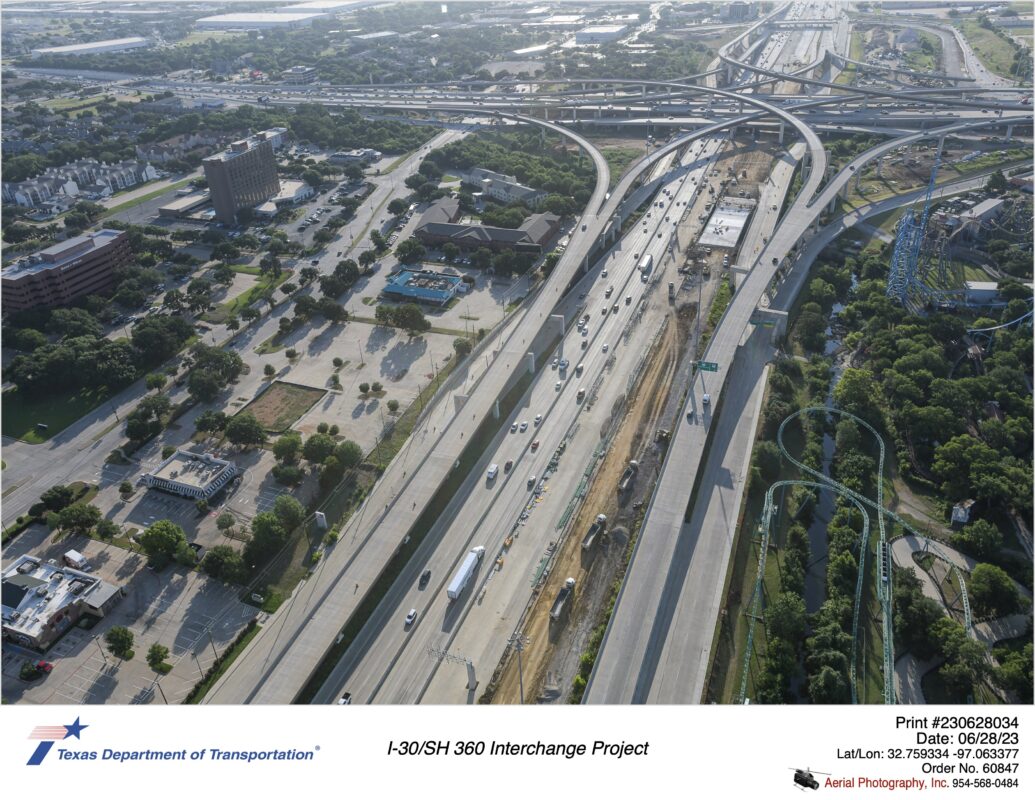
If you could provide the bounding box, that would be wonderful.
[738,406,974,704]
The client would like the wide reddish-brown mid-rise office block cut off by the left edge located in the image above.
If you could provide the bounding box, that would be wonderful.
[0,229,132,312]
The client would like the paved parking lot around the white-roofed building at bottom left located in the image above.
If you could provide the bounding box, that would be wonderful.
[2,536,257,704]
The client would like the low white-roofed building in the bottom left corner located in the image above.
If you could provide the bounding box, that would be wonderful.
[0,556,123,651]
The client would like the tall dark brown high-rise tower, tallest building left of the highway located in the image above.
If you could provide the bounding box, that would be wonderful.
[202,131,280,225]
